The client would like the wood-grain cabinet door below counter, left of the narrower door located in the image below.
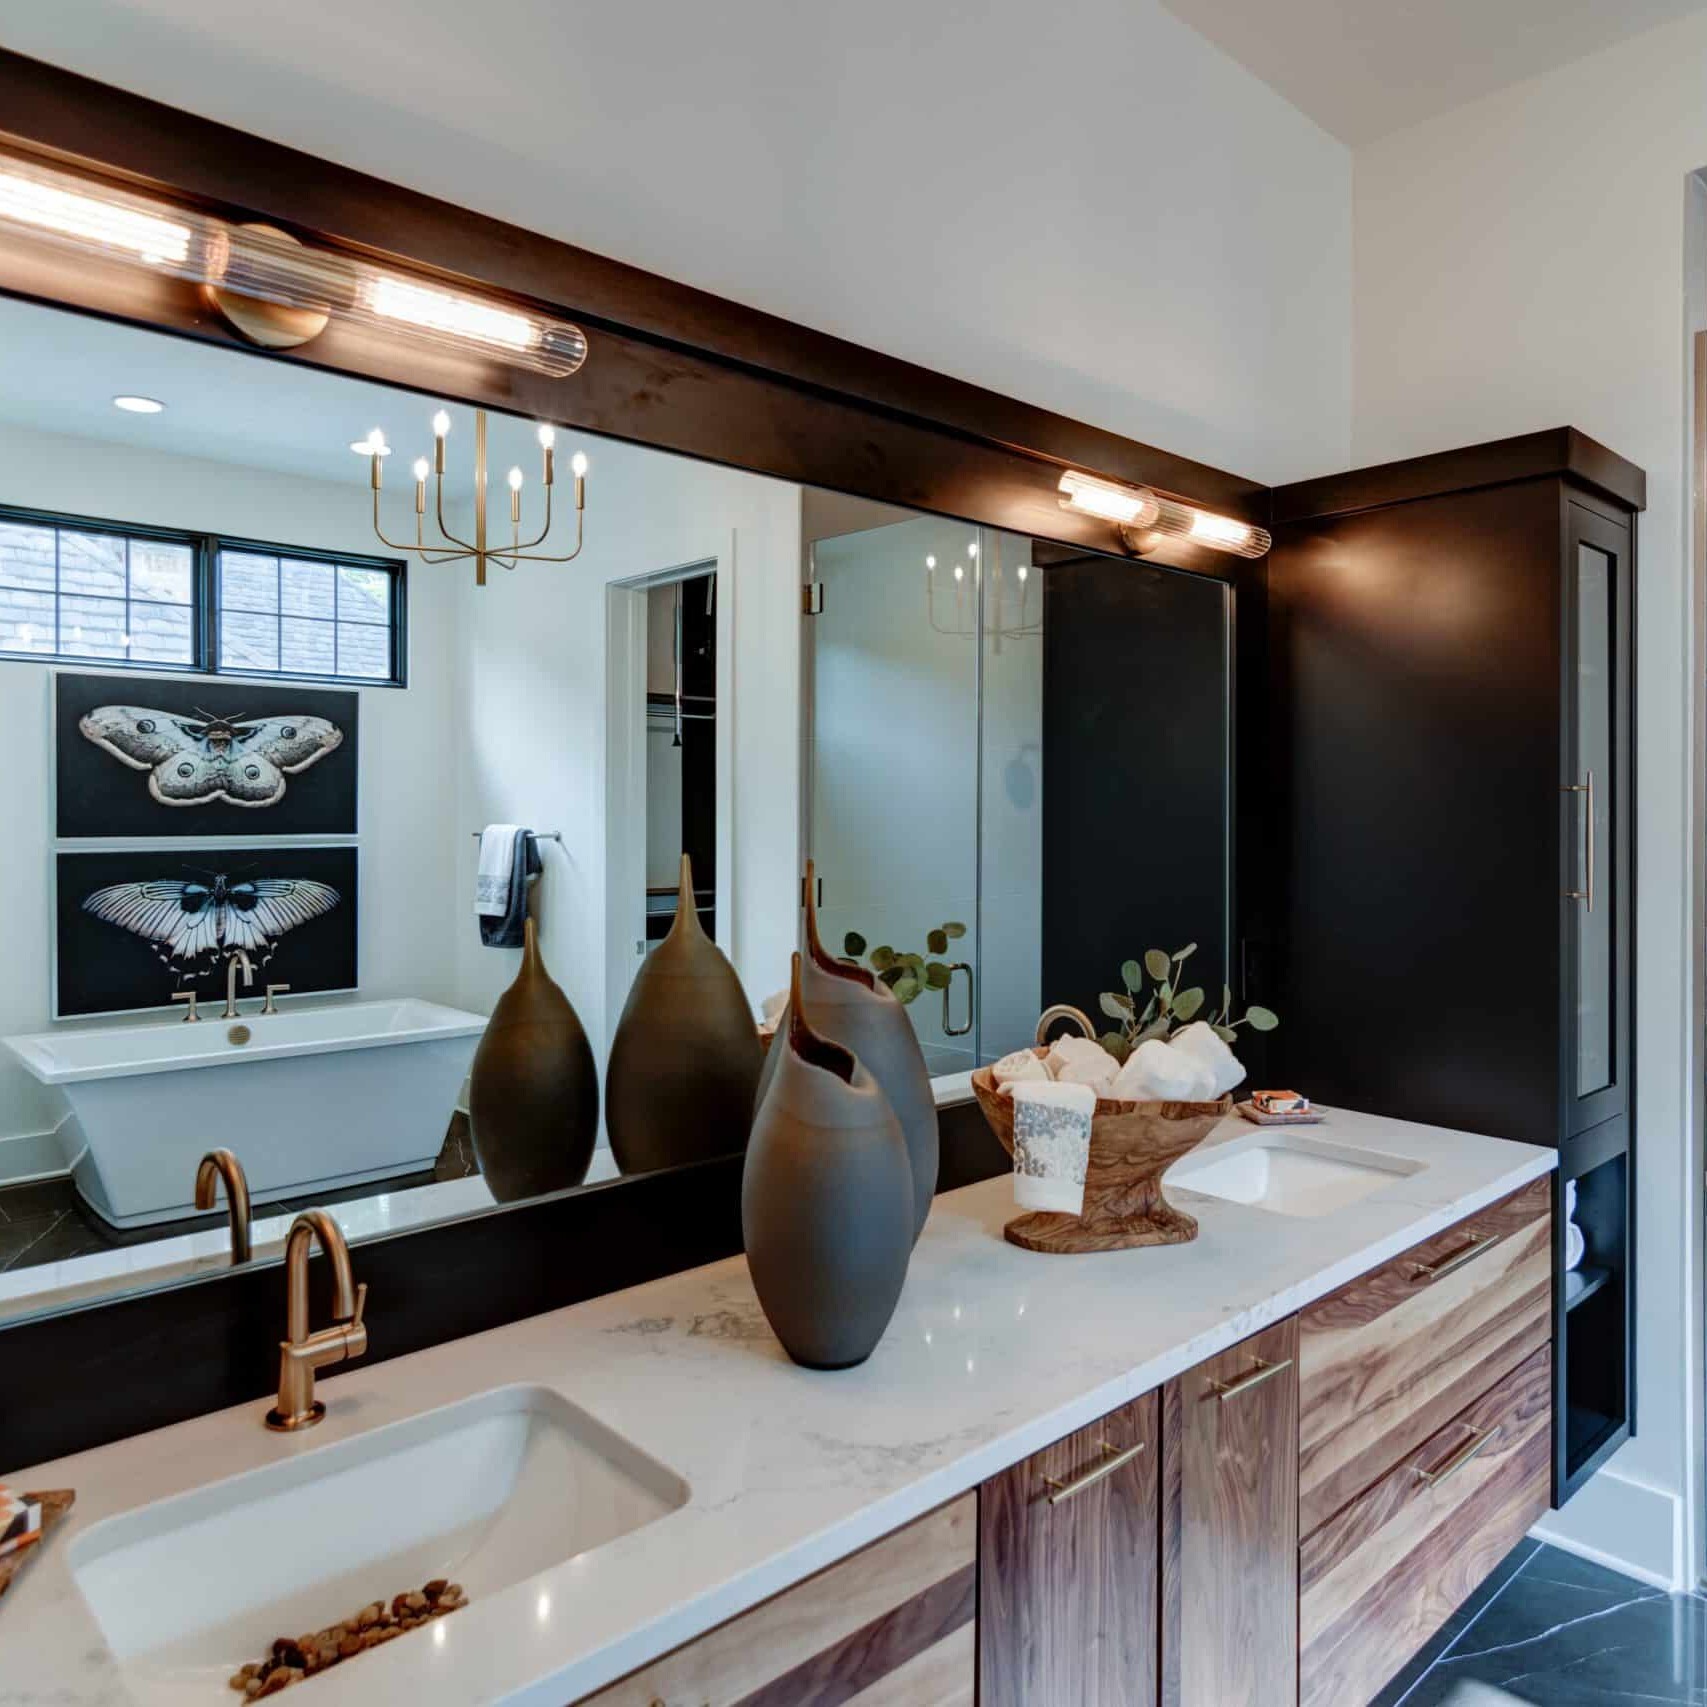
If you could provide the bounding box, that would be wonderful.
[978,1393,1161,1707]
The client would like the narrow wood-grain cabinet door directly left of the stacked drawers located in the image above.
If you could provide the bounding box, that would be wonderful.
[1162,1316,1297,1707]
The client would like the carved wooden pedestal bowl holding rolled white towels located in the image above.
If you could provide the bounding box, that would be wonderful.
[971,1048,1232,1251]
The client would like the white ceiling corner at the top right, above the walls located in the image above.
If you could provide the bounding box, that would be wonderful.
[1162,0,1707,145]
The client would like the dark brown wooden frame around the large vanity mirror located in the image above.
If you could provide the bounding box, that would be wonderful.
[0,50,1270,1470]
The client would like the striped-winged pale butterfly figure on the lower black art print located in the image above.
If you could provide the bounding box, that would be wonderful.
[82,872,343,976]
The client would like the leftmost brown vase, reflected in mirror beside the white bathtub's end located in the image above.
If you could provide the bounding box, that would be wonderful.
[468,918,599,1203]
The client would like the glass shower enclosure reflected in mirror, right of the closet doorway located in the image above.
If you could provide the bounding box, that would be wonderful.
[802,493,1043,1077]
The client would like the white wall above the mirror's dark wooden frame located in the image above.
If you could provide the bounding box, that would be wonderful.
[0,0,1350,480]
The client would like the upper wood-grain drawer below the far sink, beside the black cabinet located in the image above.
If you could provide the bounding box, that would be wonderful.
[1297,1178,1553,1535]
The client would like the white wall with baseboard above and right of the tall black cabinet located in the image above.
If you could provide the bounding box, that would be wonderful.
[1352,15,1707,1586]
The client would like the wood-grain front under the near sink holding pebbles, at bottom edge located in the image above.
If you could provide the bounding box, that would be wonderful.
[582,1494,978,1707]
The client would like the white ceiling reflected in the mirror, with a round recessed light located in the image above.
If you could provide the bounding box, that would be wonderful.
[0,297,594,493]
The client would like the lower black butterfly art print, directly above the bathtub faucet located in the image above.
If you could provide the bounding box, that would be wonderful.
[55,845,358,1019]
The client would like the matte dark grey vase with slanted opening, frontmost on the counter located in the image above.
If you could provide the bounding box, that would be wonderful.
[741,954,913,1369]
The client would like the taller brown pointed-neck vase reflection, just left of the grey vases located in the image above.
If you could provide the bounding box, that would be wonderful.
[604,854,763,1173]
